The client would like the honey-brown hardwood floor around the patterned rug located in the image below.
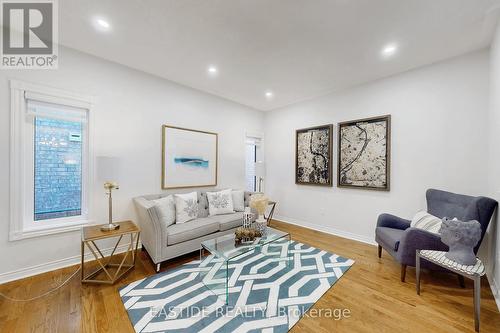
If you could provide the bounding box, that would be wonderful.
[0,221,500,333]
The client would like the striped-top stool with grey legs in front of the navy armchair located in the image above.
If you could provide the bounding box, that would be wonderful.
[416,250,485,332]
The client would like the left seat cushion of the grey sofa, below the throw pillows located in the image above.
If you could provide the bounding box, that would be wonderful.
[167,217,219,245]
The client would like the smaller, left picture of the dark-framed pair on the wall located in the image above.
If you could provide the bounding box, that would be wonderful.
[295,124,333,186]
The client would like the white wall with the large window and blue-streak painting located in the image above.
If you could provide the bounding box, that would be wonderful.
[0,48,264,283]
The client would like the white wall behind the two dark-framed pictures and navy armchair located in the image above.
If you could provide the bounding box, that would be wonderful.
[265,50,488,242]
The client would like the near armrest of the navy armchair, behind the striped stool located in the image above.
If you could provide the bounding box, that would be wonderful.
[398,227,448,266]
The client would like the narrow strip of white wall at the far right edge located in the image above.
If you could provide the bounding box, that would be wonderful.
[484,20,500,308]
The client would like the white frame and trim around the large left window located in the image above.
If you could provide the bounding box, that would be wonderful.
[9,80,94,241]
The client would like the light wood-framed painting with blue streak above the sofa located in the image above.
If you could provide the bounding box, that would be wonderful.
[161,125,218,189]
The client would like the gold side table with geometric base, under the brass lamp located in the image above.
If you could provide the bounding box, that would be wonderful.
[81,221,141,284]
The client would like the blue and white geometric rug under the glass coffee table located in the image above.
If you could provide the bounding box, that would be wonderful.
[120,241,354,333]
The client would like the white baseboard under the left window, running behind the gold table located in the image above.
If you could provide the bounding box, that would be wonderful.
[0,243,142,284]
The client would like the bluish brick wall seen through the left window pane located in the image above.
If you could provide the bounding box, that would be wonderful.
[35,117,82,220]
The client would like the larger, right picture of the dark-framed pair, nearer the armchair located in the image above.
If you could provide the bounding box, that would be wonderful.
[337,115,391,191]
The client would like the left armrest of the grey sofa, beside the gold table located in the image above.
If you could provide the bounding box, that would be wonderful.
[134,197,168,263]
